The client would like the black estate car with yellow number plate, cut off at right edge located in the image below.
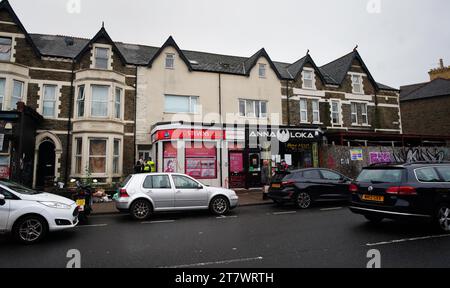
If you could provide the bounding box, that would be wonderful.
[350,163,450,232]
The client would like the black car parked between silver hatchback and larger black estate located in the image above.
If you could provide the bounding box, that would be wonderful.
[267,168,352,209]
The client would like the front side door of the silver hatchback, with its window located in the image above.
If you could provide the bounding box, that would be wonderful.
[172,175,208,208]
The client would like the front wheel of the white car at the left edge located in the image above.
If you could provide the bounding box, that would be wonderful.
[12,215,48,244]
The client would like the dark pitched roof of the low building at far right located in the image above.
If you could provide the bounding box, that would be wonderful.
[400,78,450,101]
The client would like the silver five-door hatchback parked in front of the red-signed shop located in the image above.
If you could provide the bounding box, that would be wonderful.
[115,173,239,220]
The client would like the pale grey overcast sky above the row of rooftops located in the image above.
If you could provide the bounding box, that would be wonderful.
[10,0,450,88]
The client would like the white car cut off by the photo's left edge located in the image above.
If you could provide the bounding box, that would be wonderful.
[0,181,78,244]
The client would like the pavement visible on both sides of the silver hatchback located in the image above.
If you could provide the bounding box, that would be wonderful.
[92,189,272,215]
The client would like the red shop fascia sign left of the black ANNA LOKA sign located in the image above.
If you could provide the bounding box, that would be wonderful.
[155,129,225,141]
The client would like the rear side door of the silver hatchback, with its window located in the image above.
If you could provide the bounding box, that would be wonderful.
[142,175,175,209]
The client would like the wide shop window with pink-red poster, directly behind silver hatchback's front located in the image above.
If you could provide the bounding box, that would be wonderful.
[185,142,217,179]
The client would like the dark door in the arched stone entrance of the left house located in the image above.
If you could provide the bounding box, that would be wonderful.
[36,141,56,189]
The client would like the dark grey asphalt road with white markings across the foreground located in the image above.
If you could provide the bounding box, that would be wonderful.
[0,204,450,268]
